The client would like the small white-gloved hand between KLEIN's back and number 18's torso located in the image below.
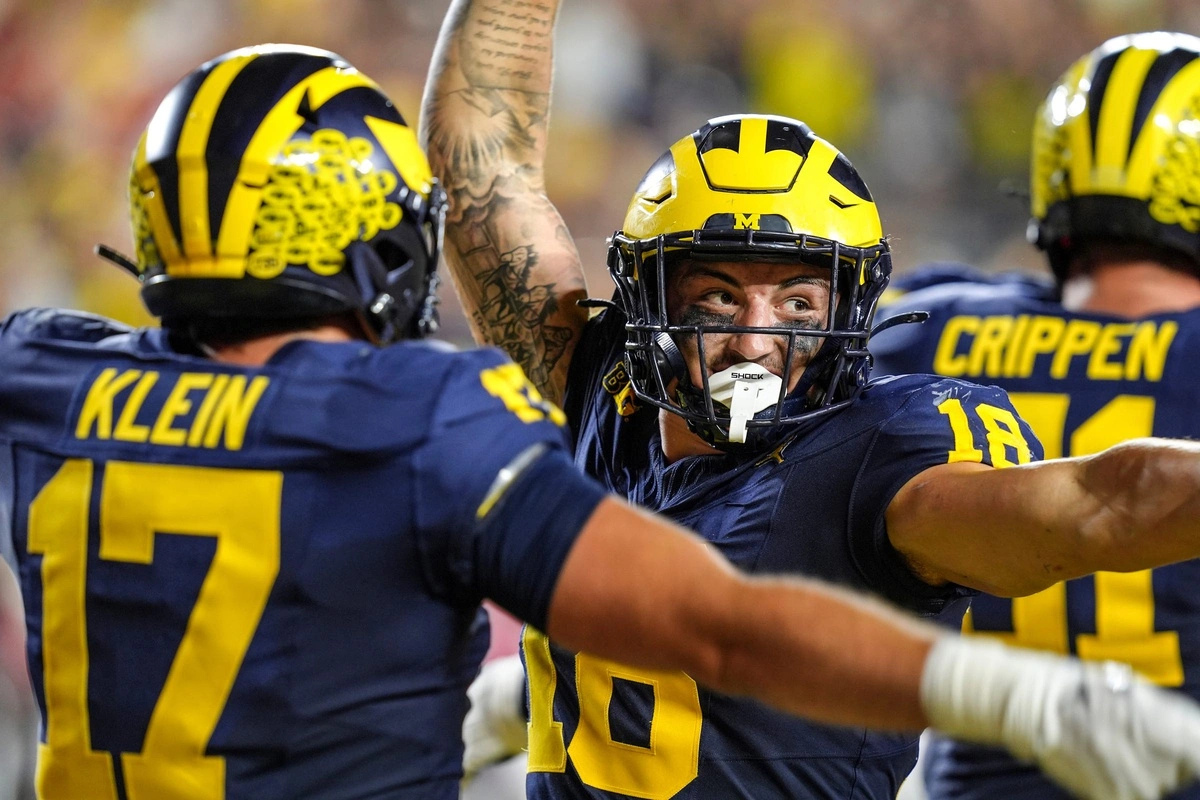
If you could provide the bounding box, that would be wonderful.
[462,656,528,777]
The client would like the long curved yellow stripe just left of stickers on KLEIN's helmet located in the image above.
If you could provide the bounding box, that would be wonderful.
[205,67,378,277]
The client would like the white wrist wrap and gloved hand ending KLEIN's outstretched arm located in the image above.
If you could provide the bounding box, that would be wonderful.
[922,637,1200,800]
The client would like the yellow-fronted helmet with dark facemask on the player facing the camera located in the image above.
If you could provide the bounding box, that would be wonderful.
[608,114,892,449]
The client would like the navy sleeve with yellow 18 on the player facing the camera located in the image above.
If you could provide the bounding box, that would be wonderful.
[850,377,1043,612]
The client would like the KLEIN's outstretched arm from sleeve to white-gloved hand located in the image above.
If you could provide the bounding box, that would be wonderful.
[547,498,1200,800]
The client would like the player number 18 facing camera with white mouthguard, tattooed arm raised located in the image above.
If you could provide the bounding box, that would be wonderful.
[421,0,1200,800]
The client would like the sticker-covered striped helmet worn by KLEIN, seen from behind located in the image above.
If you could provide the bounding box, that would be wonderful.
[102,44,445,343]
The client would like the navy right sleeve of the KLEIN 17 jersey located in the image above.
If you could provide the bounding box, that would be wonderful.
[414,351,604,627]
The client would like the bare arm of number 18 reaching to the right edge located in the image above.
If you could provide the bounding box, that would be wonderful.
[887,439,1200,596]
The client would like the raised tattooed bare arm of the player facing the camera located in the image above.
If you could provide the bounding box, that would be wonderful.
[421,0,587,402]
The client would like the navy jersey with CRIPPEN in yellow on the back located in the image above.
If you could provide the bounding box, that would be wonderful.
[870,266,1200,800]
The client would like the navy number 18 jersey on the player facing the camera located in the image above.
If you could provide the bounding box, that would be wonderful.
[523,314,1038,800]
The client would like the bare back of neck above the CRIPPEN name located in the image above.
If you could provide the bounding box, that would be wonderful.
[1062,261,1200,318]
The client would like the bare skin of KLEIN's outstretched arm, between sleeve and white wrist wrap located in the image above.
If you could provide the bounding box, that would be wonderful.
[546,498,936,730]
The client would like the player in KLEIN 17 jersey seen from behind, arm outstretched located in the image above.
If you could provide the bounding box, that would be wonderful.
[0,40,1200,800]
